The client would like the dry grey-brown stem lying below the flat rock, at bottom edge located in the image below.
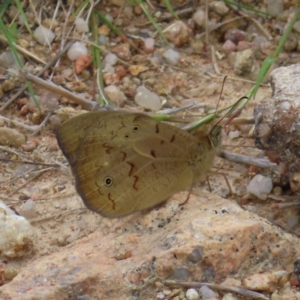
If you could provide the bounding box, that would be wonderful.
[164,280,269,300]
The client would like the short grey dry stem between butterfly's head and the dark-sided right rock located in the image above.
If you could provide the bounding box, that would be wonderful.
[217,150,277,169]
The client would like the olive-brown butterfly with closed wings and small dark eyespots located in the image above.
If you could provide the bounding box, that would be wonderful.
[57,111,220,218]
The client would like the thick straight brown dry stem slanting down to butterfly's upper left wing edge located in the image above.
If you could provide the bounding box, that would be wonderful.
[25,73,98,110]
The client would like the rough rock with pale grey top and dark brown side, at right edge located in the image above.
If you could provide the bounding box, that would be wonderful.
[254,64,300,192]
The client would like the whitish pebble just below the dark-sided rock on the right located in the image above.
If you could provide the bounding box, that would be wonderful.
[247,174,273,200]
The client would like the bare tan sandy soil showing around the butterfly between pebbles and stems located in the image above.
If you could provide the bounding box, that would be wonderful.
[0,1,300,296]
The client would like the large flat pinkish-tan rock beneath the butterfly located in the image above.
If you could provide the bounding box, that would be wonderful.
[0,191,300,300]
